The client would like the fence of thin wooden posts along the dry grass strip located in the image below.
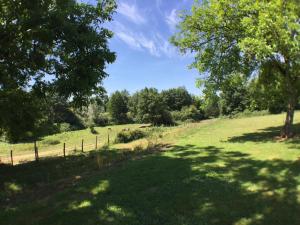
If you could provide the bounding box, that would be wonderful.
[0,136,109,165]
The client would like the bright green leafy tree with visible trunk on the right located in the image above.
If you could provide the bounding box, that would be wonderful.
[171,0,300,137]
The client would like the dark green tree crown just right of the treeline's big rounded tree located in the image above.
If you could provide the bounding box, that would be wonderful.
[161,87,193,111]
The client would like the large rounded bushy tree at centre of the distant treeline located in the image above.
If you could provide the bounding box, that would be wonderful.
[129,88,173,125]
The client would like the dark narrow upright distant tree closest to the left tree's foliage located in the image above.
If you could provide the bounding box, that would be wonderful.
[107,90,129,124]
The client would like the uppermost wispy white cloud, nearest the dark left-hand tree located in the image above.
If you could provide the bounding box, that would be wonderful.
[117,2,146,24]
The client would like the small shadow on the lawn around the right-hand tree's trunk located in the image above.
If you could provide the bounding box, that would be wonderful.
[228,123,300,144]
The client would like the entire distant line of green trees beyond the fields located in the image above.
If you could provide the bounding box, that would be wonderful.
[5,81,300,142]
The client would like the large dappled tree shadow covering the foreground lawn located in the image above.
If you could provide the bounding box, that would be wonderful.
[0,145,300,225]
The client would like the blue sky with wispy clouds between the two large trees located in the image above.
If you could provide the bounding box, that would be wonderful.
[104,0,200,94]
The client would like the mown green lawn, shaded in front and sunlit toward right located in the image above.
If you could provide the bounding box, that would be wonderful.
[0,112,300,225]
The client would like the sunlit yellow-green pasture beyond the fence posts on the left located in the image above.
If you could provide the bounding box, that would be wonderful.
[0,124,154,163]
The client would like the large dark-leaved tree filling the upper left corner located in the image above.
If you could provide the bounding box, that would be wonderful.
[0,0,116,141]
